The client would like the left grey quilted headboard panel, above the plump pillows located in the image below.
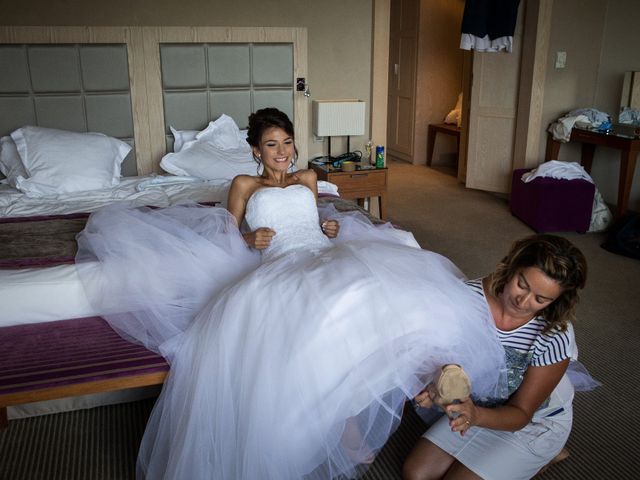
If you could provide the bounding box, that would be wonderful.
[0,44,137,176]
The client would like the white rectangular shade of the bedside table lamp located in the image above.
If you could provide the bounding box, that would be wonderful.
[312,100,365,137]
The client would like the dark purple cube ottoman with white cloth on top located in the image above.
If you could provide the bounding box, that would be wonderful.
[511,168,596,233]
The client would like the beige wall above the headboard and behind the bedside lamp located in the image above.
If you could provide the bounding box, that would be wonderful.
[0,0,376,161]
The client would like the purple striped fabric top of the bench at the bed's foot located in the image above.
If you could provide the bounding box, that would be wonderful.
[0,317,169,395]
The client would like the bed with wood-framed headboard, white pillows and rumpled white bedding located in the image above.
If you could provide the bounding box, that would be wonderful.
[0,26,376,418]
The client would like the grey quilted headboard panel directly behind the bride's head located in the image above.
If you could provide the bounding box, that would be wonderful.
[160,43,294,150]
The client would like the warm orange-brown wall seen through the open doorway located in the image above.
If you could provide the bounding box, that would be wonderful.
[413,0,464,165]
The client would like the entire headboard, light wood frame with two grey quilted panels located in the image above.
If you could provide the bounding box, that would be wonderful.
[0,25,310,175]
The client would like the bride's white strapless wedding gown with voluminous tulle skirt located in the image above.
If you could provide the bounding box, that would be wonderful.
[78,185,504,480]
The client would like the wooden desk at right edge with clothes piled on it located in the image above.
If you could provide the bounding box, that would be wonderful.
[545,128,640,216]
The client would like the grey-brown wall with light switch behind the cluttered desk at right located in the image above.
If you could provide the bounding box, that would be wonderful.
[540,0,640,211]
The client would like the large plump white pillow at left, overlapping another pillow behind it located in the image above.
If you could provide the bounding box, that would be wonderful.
[11,126,131,197]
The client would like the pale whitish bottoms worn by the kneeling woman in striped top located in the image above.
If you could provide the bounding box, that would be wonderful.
[423,403,573,480]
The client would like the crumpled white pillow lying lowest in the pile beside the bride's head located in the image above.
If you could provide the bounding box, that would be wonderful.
[160,140,258,180]
